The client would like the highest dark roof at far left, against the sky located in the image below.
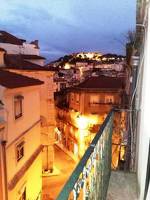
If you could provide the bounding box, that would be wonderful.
[0,31,26,45]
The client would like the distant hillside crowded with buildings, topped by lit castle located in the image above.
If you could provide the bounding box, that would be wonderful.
[48,52,127,91]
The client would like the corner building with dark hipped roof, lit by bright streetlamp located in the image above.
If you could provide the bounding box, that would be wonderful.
[56,77,126,168]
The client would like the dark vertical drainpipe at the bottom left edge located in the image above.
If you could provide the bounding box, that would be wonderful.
[1,140,8,200]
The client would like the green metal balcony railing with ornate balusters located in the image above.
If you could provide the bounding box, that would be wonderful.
[57,111,113,200]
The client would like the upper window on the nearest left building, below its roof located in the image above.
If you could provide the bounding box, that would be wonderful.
[14,95,23,119]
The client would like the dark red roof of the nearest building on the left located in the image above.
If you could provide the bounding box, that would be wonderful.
[0,70,43,89]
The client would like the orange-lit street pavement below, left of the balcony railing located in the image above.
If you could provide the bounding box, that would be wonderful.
[42,145,77,200]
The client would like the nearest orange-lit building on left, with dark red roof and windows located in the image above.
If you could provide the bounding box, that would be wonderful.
[0,70,43,200]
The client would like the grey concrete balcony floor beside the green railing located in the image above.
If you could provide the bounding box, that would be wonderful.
[106,171,138,200]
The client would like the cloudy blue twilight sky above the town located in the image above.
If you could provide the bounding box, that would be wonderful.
[0,0,136,60]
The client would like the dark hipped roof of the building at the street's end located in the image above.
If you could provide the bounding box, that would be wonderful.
[74,76,124,90]
